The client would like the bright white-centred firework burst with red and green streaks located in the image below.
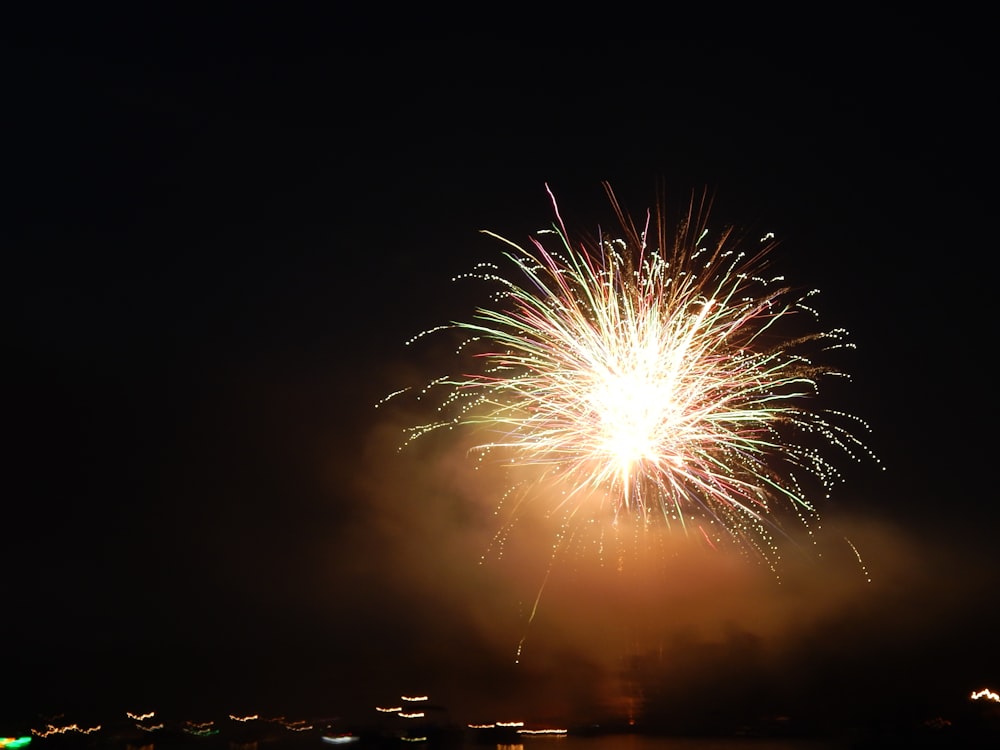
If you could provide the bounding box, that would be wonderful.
[382,186,874,568]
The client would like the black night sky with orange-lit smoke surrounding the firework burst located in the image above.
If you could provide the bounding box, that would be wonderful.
[0,8,1000,736]
